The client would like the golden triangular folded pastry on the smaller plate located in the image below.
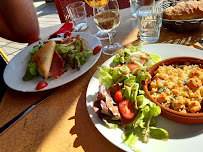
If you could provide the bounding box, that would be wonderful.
[32,40,56,79]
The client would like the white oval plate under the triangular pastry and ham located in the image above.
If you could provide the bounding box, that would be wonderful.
[3,32,102,92]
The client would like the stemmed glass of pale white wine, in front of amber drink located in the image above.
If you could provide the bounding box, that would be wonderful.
[93,0,123,55]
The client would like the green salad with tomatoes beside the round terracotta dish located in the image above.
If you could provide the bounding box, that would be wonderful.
[94,45,168,150]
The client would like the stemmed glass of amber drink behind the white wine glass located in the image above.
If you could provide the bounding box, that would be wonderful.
[85,0,116,40]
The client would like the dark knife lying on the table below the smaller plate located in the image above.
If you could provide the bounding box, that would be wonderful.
[0,87,61,135]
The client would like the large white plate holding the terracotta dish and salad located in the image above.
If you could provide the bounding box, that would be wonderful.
[86,44,203,152]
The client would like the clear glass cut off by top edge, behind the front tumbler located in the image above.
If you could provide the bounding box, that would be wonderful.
[130,0,155,18]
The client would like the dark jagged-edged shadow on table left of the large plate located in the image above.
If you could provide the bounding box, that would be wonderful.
[69,89,122,152]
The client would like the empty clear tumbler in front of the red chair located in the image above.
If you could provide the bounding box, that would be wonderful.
[66,2,88,30]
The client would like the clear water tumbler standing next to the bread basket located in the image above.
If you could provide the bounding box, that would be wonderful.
[136,6,162,43]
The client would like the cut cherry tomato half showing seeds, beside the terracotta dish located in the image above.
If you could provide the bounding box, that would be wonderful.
[119,99,135,119]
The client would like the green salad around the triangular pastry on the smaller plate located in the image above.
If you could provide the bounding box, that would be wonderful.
[22,35,93,81]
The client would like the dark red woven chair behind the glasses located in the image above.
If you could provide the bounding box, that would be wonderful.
[54,0,130,23]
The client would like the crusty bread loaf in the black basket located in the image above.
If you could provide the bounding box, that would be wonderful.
[163,1,203,20]
